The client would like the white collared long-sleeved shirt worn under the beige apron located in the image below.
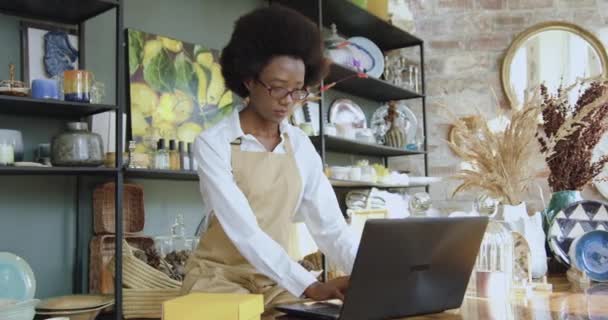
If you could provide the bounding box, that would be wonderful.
[194,111,359,297]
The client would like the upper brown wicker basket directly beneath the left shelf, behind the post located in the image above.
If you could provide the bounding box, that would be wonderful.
[93,182,145,235]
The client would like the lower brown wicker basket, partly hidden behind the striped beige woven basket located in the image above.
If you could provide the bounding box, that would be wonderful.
[89,235,160,294]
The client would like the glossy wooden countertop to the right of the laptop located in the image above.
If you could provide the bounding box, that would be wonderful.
[277,276,608,320]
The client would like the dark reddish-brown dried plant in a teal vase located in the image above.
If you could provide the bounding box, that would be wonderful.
[537,80,608,226]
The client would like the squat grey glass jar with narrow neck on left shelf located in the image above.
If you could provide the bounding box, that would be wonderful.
[51,122,104,167]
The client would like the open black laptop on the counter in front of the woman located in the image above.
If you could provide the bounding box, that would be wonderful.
[276,217,488,320]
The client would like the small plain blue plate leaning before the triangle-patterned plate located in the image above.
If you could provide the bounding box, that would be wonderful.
[570,230,608,282]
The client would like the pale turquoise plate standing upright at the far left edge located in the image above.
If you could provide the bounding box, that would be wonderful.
[0,252,36,301]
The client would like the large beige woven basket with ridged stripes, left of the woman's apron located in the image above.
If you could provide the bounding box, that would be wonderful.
[108,242,182,319]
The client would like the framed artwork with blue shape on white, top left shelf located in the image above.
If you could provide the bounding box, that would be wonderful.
[21,21,81,84]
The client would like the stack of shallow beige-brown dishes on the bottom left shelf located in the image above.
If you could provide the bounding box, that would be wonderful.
[36,295,114,320]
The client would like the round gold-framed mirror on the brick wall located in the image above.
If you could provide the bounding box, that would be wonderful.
[502,22,608,107]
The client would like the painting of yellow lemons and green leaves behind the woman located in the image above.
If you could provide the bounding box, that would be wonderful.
[128,29,233,152]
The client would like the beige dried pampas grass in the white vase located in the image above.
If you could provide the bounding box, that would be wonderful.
[448,96,540,205]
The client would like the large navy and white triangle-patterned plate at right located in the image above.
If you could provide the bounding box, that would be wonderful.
[547,200,608,267]
